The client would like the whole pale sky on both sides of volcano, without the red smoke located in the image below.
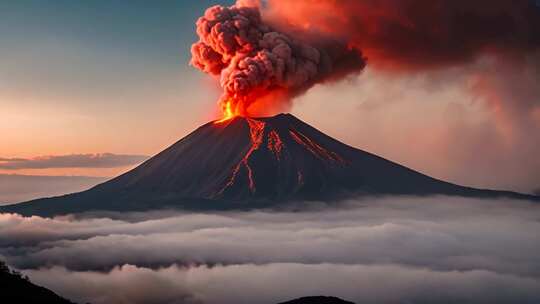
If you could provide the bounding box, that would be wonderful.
[0,0,540,197]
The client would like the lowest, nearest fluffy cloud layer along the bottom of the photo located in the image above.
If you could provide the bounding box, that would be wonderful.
[25,263,540,304]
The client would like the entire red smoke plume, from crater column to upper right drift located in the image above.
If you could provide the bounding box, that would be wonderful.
[192,0,540,119]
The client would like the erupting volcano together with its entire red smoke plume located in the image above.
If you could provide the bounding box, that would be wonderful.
[0,0,538,215]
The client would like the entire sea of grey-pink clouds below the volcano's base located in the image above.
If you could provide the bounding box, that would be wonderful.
[0,196,540,304]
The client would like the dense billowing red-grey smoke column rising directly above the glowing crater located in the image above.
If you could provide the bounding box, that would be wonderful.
[191,1,365,115]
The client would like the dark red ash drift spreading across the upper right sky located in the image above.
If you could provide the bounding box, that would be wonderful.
[267,0,540,70]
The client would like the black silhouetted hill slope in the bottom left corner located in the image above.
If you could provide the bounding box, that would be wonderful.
[0,261,74,304]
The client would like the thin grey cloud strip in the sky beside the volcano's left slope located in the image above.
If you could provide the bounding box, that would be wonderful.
[0,153,148,170]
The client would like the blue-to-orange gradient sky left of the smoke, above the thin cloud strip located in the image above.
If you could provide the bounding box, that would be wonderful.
[0,0,228,162]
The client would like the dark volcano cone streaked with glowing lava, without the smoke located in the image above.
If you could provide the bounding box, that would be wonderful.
[0,114,537,216]
